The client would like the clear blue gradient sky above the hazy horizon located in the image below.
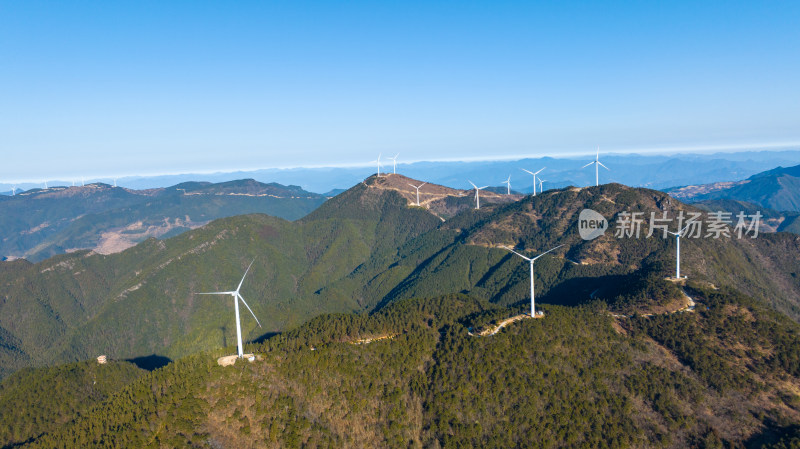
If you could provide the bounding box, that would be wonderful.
[0,0,800,181]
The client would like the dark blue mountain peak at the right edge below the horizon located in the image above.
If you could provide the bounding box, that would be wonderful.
[667,165,800,212]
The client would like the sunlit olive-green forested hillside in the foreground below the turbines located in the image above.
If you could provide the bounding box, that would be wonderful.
[10,285,800,448]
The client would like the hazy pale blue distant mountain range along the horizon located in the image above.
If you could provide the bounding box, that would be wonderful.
[0,148,800,196]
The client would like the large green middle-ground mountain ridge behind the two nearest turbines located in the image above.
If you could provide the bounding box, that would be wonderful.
[0,177,800,384]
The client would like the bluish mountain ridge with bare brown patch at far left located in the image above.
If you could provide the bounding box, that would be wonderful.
[0,179,326,261]
